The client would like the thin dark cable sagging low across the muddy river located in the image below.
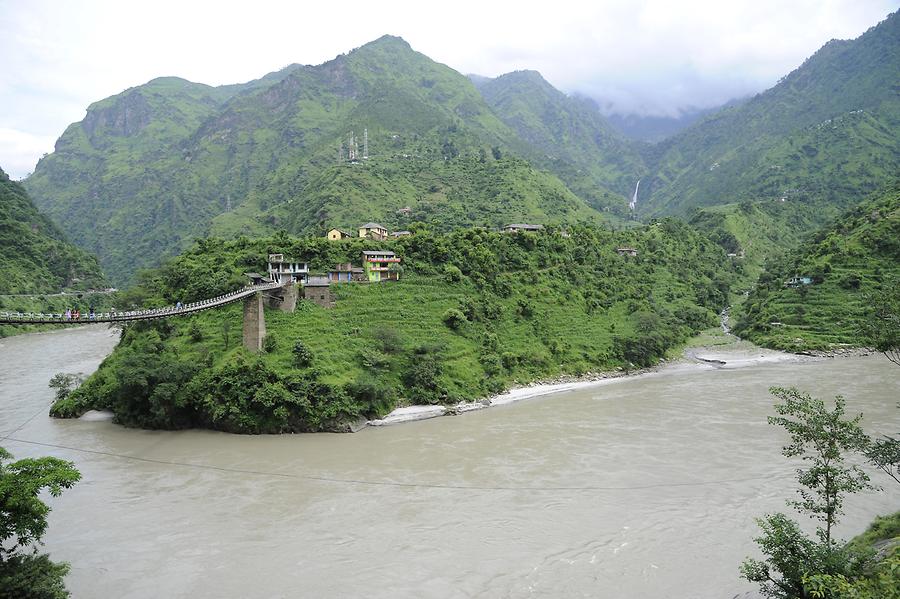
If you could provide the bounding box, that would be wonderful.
[6,436,768,491]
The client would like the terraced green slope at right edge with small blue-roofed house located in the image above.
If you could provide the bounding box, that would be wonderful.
[735,186,900,350]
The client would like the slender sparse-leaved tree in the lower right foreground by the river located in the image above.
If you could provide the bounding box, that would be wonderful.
[741,387,871,599]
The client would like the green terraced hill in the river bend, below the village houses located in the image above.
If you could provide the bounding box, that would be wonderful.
[54,220,733,433]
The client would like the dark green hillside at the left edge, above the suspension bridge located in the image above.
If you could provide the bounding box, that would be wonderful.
[0,169,104,294]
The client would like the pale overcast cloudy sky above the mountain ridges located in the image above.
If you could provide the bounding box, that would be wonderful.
[0,0,900,178]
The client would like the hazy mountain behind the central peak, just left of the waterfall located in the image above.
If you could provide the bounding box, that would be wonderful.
[474,71,647,215]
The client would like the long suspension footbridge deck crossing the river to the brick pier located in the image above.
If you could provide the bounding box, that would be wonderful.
[0,283,281,325]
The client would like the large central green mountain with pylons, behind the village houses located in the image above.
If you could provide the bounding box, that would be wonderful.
[26,36,601,281]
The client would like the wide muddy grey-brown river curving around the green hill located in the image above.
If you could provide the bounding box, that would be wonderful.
[0,326,900,599]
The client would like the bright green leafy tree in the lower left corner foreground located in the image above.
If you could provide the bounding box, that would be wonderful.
[0,447,81,599]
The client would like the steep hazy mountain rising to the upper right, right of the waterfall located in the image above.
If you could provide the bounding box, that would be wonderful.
[638,12,900,215]
